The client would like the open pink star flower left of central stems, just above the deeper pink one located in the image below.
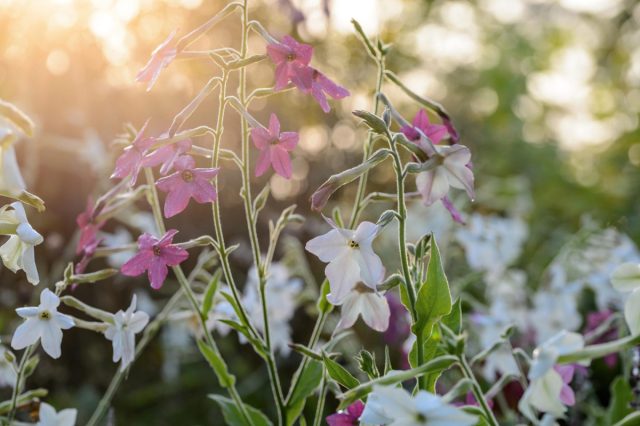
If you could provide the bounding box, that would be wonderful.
[156,155,219,218]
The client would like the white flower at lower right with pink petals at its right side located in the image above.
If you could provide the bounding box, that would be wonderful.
[518,331,584,419]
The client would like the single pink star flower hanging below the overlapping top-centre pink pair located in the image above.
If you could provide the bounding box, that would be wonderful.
[251,114,298,179]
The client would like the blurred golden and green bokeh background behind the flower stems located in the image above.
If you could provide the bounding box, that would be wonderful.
[0,0,640,425]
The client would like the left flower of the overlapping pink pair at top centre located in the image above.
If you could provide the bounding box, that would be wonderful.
[267,36,313,90]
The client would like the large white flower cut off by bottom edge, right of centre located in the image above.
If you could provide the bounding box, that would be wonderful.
[360,386,478,426]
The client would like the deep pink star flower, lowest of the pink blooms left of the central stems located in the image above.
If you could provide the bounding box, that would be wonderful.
[121,229,189,290]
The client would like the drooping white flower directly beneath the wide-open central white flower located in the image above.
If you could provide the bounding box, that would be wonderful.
[336,283,390,332]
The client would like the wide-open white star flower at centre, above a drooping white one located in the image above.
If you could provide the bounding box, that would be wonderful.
[306,220,384,304]
